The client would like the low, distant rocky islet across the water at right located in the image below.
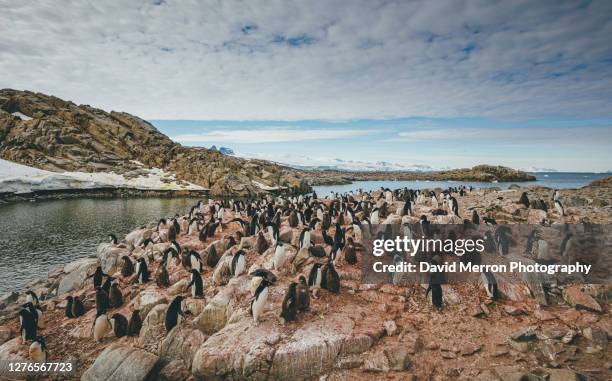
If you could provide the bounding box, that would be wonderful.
[306,165,536,185]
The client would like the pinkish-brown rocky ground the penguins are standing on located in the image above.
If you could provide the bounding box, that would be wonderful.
[0,182,612,381]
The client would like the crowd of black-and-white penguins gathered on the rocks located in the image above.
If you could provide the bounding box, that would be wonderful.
[13,187,572,362]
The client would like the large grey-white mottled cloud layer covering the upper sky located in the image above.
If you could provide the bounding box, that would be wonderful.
[0,0,612,120]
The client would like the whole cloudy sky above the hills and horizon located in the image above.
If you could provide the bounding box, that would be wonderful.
[0,0,612,171]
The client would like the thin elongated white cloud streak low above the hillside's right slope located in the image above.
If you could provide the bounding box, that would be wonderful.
[170,128,376,144]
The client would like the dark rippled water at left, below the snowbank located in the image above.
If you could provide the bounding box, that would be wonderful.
[0,198,198,295]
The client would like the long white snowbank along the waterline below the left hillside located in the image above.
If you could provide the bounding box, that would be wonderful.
[0,159,206,193]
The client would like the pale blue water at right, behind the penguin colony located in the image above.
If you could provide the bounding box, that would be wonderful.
[314,172,612,196]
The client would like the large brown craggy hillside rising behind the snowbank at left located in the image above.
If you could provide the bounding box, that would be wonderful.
[0,89,310,195]
